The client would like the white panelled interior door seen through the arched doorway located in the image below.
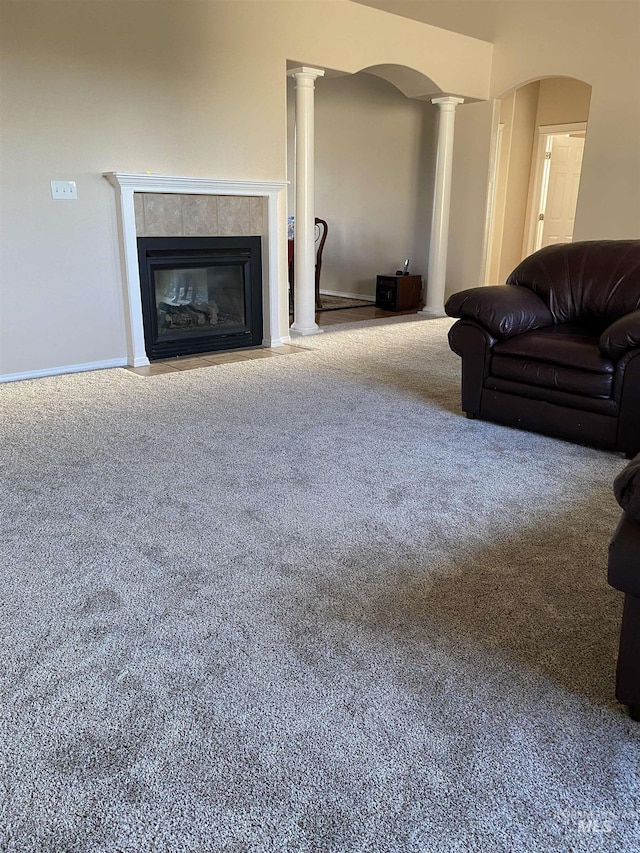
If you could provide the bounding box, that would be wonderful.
[538,135,584,248]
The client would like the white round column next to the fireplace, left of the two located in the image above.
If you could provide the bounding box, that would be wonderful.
[288,66,324,335]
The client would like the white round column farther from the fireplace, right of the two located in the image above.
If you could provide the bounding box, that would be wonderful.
[421,97,464,317]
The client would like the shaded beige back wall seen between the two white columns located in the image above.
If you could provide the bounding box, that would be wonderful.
[289,74,435,297]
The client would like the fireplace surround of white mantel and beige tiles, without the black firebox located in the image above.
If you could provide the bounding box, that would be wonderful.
[105,172,290,367]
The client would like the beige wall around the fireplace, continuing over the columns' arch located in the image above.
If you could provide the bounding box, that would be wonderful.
[0,0,492,376]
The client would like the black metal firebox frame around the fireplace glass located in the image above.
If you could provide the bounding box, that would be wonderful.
[138,237,263,361]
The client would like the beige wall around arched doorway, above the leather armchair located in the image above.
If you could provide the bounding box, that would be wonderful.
[492,2,640,240]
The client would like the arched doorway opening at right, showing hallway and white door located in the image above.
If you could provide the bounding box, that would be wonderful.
[484,77,591,284]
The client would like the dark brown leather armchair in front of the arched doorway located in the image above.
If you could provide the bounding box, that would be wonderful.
[445,240,640,458]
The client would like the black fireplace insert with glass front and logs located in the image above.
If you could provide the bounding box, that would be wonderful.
[138,236,262,361]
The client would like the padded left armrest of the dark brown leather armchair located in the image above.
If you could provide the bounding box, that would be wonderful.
[444,284,553,338]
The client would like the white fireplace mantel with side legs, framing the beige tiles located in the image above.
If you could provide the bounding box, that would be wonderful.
[104,172,290,367]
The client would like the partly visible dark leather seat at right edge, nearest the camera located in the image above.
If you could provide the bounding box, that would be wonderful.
[608,455,640,720]
